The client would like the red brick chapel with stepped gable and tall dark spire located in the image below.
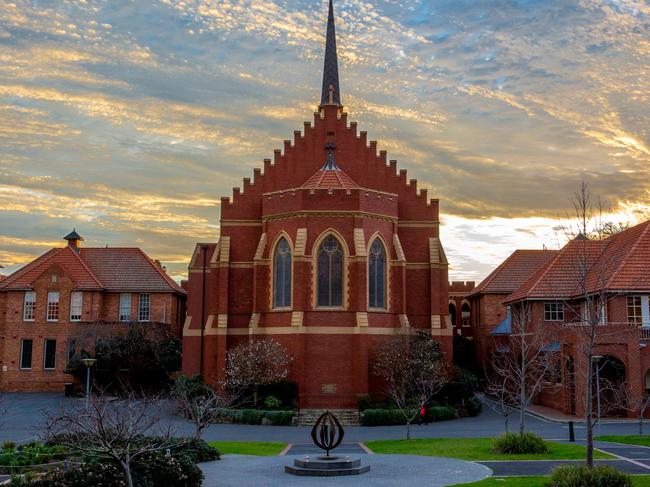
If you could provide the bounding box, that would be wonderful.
[183,1,452,408]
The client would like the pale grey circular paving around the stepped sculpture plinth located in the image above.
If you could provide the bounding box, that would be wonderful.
[200,455,492,487]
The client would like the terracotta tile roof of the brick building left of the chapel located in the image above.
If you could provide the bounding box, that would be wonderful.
[0,246,185,293]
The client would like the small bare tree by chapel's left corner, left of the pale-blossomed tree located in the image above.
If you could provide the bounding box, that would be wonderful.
[172,376,241,440]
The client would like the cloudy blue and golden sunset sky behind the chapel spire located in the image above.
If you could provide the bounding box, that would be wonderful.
[0,0,650,281]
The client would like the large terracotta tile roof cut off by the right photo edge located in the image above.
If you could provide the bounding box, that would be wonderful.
[507,221,650,302]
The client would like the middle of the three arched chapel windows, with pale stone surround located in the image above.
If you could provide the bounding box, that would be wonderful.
[318,235,343,307]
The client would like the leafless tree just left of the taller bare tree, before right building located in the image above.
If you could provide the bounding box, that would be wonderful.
[491,302,559,435]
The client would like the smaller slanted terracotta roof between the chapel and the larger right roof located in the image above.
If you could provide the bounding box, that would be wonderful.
[470,250,557,296]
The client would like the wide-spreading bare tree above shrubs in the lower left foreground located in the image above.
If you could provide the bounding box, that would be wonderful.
[44,393,178,487]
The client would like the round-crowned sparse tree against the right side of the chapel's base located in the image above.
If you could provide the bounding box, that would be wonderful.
[375,332,449,440]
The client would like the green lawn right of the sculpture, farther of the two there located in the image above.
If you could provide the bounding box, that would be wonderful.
[366,438,613,462]
